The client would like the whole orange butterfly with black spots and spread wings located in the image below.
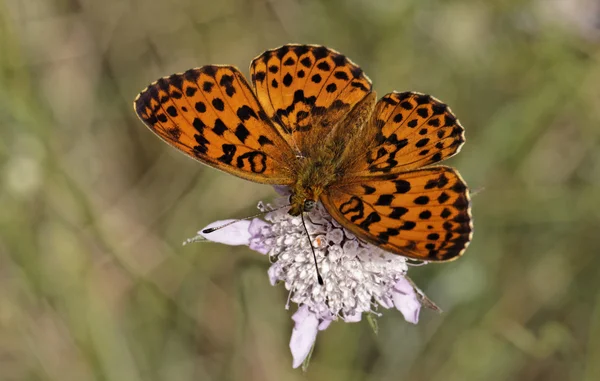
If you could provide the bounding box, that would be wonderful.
[134,44,472,262]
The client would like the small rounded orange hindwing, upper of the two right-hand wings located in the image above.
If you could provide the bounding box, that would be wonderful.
[352,92,465,176]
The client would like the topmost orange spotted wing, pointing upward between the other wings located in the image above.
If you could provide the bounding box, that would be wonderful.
[250,45,372,156]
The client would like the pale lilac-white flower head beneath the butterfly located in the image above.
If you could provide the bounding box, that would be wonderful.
[187,197,424,368]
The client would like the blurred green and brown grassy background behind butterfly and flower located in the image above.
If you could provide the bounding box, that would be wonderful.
[0,0,600,381]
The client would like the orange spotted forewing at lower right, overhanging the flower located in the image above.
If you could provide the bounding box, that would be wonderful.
[321,166,472,261]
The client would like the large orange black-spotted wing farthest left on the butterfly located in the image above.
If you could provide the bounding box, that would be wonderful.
[134,66,295,184]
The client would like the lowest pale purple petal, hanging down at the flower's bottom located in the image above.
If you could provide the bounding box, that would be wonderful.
[290,306,319,368]
